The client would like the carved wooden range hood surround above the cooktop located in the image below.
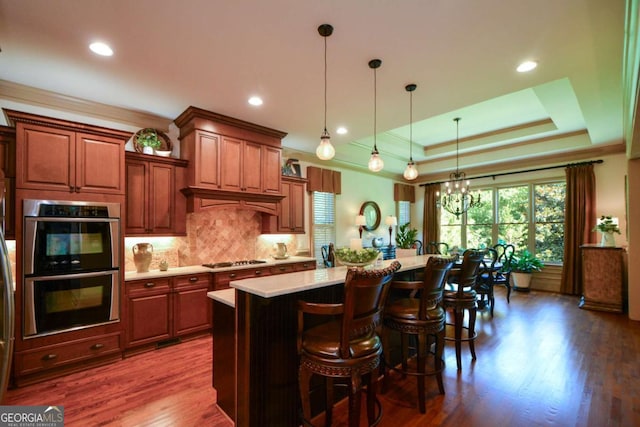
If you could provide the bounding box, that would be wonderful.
[174,106,287,215]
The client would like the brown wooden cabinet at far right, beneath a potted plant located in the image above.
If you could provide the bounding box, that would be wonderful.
[579,245,626,313]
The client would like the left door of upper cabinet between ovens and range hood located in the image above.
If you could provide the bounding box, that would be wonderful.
[125,160,149,234]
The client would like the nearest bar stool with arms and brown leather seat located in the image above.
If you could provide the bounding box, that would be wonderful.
[297,261,400,427]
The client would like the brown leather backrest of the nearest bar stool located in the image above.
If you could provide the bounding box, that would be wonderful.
[340,261,400,359]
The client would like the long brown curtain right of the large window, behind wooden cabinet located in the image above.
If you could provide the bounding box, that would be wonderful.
[560,164,597,295]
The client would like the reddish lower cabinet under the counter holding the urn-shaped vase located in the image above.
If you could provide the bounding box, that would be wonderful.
[125,273,212,350]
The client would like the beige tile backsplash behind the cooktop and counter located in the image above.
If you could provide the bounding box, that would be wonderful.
[124,209,304,271]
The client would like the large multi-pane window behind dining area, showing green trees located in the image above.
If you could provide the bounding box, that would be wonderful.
[440,181,566,263]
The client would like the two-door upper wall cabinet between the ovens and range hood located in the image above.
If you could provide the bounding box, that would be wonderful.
[125,152,187,236]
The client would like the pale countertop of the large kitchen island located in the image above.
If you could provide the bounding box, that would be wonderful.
[229,255,432,298]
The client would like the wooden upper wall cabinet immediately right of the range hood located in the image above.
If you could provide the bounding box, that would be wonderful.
[262,176,306,234]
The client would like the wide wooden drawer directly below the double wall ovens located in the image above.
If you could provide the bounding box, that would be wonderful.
[15,333,120,375]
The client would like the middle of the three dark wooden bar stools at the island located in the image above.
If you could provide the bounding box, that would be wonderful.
[383,256,455,414]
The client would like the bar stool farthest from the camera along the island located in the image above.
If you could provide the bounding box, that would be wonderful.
[443,249,486,369]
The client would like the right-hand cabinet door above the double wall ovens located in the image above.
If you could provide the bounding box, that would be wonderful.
[75,133,125,194]
